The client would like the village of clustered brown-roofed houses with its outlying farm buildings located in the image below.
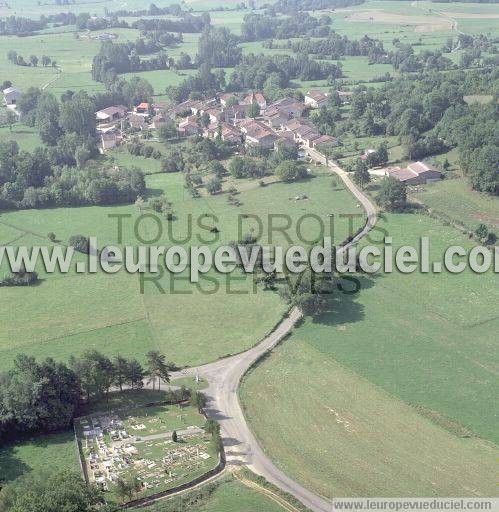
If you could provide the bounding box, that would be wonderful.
[3,87,442,185]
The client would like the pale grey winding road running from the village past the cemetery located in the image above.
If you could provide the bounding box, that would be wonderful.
[172,156,376,512]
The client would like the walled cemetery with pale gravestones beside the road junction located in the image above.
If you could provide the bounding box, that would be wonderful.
[75,405,218,501]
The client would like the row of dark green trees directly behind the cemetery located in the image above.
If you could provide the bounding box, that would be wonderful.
[0,350,183,440]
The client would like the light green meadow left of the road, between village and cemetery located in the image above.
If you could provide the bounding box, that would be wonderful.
[0,170,362,369]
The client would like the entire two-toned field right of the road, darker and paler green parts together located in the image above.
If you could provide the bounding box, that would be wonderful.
[241,214,499,496]
